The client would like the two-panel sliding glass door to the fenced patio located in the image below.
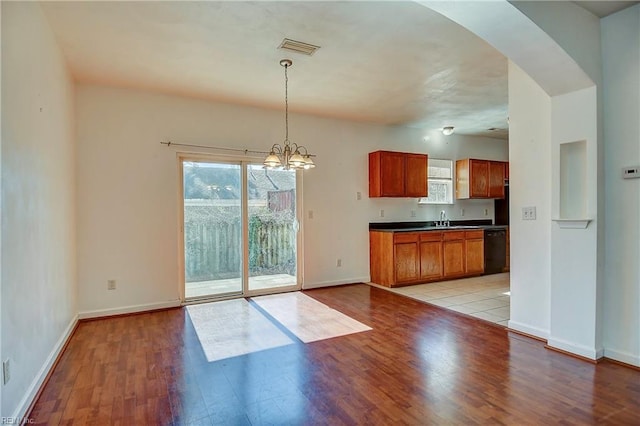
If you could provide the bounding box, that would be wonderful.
[180,157,299,300]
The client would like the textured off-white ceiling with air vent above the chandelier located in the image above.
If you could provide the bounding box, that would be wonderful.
[43,2,507,138]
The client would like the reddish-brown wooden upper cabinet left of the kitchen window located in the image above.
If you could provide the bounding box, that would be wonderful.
[369,151,428,198]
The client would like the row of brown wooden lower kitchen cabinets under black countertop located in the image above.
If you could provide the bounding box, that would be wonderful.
[369,230,484,287]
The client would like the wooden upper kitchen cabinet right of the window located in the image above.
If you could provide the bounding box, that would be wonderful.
[456,158,507,199]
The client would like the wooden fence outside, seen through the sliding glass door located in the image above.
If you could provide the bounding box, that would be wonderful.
[184,216,296,282]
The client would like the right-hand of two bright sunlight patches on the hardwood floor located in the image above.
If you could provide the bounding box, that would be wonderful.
[252,291,371,343]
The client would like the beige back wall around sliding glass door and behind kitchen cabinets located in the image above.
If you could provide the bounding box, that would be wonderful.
[77,86,507,315]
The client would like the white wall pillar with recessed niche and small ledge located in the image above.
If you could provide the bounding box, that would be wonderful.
[548,86,604,359]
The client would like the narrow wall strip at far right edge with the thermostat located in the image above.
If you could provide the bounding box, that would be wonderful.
[602,5,640,366]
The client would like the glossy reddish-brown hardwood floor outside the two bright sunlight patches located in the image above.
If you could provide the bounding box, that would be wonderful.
[30,284,640,425]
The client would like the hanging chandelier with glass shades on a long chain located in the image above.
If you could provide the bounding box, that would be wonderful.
[264,59,316,170]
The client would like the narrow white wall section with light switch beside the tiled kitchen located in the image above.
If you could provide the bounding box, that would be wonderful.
[509,61,551,338]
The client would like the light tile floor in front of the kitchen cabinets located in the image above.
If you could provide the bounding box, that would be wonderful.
[369,272,510,327]
